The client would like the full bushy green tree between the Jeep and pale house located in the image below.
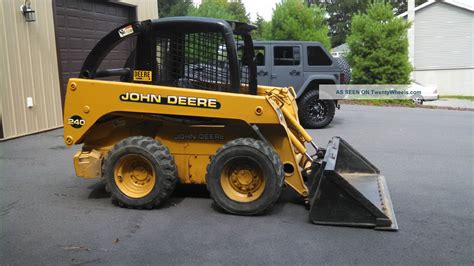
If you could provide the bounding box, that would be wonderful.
[347,3,412,84]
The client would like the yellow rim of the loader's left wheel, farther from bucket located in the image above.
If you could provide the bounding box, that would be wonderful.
[114,154,156,198]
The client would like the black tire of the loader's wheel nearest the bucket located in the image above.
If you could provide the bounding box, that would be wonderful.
[206,138,284,215]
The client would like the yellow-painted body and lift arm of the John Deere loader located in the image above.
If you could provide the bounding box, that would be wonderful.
[64,79,308,197]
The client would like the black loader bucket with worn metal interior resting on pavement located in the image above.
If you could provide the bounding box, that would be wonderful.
[309,137,398,231]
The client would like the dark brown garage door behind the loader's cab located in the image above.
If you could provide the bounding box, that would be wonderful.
[53,0,136,105]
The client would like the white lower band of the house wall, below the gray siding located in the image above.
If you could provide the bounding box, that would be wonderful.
[415,68,474,96]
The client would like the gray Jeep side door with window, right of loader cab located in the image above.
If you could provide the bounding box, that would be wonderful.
[270,44,303,90]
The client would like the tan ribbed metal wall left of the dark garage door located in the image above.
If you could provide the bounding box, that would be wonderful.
[0,0,62,138]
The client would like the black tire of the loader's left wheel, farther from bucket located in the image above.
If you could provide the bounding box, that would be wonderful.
[103,136,178,209]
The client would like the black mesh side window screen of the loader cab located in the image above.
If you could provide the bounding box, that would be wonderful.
[156,32,231,91]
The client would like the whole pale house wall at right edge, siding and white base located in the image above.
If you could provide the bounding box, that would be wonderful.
[414,2,474,95]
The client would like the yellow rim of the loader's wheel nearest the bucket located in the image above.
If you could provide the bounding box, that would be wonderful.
[220,159,265,202]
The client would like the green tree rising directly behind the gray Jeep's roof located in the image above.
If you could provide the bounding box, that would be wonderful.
[271,0,331,48]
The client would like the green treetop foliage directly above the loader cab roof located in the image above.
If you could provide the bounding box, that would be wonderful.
[189,0,250,22]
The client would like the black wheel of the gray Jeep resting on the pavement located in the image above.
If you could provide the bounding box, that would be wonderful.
[298,90,336,129]
